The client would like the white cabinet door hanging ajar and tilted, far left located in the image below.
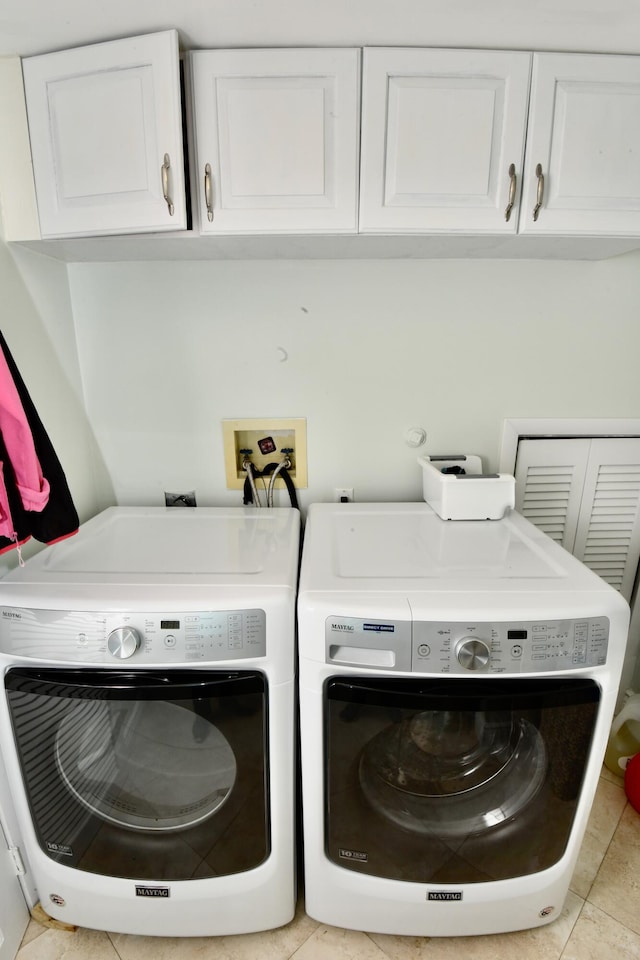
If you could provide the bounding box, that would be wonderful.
[23,30,186,238]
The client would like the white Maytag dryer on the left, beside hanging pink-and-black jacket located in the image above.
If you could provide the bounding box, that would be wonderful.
[0,507,300,936]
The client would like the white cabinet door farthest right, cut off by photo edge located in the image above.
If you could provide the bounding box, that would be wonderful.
[520,53,640,235]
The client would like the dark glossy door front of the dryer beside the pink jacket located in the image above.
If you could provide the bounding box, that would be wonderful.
[5,669,270,880]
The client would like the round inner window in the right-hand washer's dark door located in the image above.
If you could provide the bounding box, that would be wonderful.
[359,709,547,837]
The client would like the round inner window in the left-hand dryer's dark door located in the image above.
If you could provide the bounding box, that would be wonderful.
[55,700,237,833]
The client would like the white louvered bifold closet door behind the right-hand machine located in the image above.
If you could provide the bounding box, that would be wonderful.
[515,437,640,600]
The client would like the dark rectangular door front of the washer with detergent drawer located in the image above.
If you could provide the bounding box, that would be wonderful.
[325,677,600,883]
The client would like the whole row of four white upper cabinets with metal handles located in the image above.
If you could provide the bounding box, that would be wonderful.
[12,39,640,256]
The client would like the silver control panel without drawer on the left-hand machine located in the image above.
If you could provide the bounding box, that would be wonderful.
[0,607,267,666]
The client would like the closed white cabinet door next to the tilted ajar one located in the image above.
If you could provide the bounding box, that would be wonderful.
[189,49,360,234]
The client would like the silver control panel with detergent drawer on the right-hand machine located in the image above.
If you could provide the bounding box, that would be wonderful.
[325,617,609,675]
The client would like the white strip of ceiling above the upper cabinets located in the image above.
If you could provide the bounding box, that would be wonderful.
[0,0,640,56]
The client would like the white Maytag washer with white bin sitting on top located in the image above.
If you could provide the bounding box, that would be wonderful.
[298,503,629,937]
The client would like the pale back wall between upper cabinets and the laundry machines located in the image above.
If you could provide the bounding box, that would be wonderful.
[69,254,640,505]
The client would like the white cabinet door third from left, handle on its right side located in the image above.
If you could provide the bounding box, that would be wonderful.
[360,48,531,233]
